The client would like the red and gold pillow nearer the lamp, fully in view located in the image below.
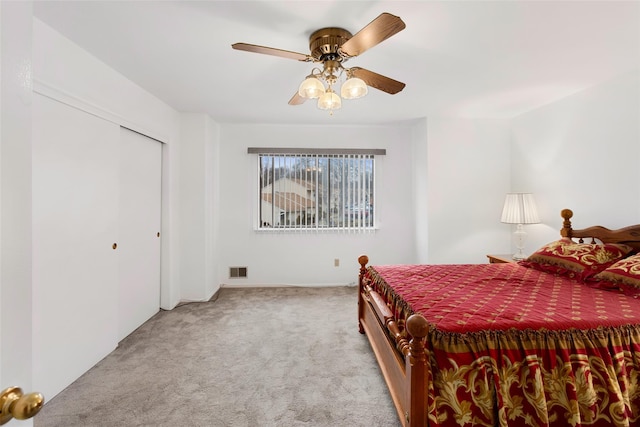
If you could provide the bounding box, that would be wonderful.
[519,238,633,281]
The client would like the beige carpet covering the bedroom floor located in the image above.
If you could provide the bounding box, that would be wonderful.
[34,287,399,427]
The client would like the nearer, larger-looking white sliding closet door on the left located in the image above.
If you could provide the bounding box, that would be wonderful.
[32,94,120,399]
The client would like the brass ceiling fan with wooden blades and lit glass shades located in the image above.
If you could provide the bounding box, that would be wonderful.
[231,12,406,112]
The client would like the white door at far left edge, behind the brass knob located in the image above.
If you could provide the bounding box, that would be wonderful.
[0,1,32,408]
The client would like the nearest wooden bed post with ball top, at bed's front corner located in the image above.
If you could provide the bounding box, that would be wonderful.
[405,314,429,427]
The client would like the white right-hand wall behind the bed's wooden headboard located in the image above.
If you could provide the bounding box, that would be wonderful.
[511,71,640,252]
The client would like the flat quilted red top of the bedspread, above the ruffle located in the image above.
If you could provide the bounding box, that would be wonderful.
[368,263,640,332]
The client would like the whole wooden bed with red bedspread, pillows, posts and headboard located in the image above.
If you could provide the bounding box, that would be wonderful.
[358,209,640,427]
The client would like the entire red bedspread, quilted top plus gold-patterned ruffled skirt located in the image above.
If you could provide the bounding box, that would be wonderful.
[366,263,640,426]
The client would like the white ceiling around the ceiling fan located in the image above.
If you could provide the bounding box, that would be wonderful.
[34,0,640,125]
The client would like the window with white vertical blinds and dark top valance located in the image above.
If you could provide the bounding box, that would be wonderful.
[249,149,384,231]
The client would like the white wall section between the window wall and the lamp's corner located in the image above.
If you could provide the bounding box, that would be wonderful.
[420,117,510,264]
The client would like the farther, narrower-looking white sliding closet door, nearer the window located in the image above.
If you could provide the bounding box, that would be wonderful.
[118,128,162,339]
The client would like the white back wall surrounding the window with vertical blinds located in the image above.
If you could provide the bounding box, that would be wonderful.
[218,124,415,286]
